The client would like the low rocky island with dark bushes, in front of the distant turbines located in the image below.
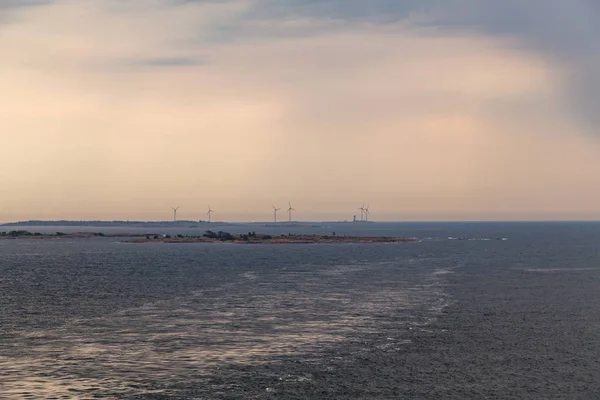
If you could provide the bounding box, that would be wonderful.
[126,231,416,244]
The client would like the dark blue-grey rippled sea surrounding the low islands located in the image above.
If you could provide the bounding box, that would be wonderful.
[0,223,600,399]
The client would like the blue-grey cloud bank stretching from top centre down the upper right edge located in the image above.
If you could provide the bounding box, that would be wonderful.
[262,0,600,132]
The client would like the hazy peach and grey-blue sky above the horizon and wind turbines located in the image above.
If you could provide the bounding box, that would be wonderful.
[0,0,600,222]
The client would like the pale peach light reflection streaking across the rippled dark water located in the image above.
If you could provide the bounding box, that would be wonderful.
[0,253,446,399]
